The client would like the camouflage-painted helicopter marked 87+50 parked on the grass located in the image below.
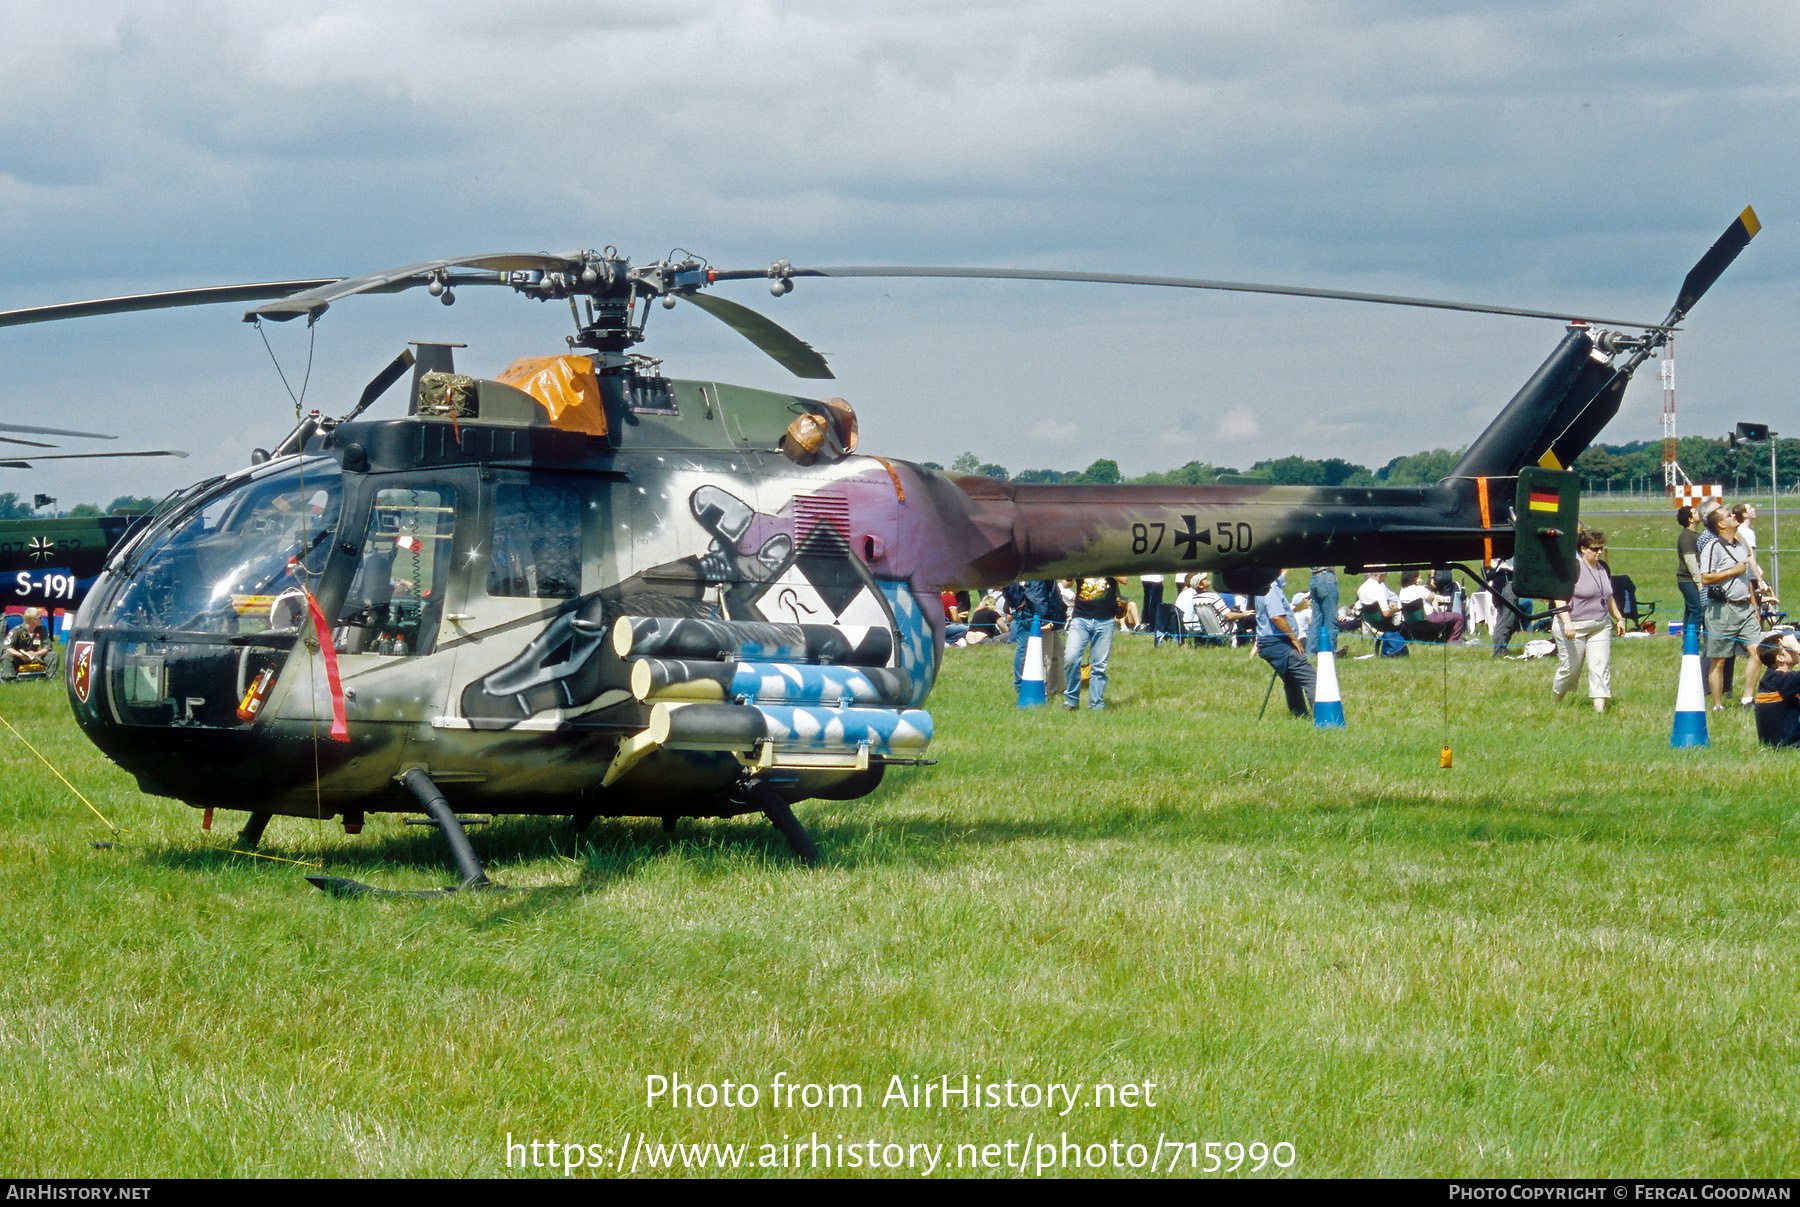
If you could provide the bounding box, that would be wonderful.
[0,209,1759,890]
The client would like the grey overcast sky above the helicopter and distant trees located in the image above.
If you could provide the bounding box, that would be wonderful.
[0,0,1800,505]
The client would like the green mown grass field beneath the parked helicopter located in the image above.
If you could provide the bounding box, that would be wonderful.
[0,492,1800,1176]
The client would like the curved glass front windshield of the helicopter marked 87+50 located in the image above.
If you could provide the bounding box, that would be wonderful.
[108,459,342,635]
